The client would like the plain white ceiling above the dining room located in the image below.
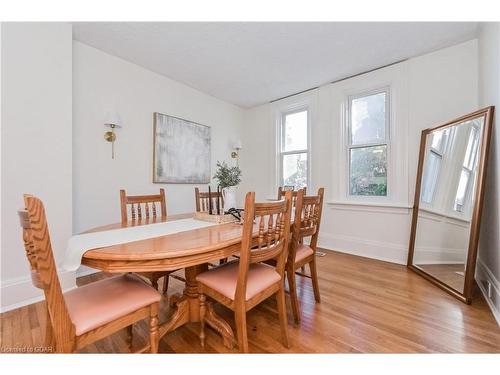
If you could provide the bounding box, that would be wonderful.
[73,22,477,108]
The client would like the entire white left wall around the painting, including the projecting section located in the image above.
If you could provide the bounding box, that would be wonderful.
[1,34,244,310]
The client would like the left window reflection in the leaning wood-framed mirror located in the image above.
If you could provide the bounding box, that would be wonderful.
[420,129,450,204]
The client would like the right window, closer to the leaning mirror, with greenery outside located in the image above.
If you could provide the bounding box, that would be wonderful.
[346,88,390,197]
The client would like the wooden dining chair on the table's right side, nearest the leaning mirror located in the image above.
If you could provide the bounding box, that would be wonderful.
[286,188,324,324]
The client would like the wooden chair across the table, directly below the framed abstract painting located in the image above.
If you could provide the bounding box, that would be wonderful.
[120,189,175,295]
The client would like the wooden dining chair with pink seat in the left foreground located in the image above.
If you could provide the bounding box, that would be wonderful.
[18,195,161,353]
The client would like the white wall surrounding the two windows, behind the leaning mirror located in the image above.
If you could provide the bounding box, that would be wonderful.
[241,40,478,264]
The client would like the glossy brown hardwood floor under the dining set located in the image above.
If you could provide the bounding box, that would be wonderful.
[0,251,500,353]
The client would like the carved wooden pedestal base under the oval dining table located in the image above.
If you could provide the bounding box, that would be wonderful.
[159,263,235,349]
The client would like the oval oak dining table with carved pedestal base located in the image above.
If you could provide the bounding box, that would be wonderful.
[82,214,243,349]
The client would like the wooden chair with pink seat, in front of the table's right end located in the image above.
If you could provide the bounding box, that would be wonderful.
[196,192,291,353]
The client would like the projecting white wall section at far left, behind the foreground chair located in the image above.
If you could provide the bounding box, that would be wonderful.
[1,23,72,308]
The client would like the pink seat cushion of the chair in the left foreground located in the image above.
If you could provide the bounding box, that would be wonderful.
[64,274,161,336]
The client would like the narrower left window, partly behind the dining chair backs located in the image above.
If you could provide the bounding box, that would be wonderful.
[279,108,309,190]
